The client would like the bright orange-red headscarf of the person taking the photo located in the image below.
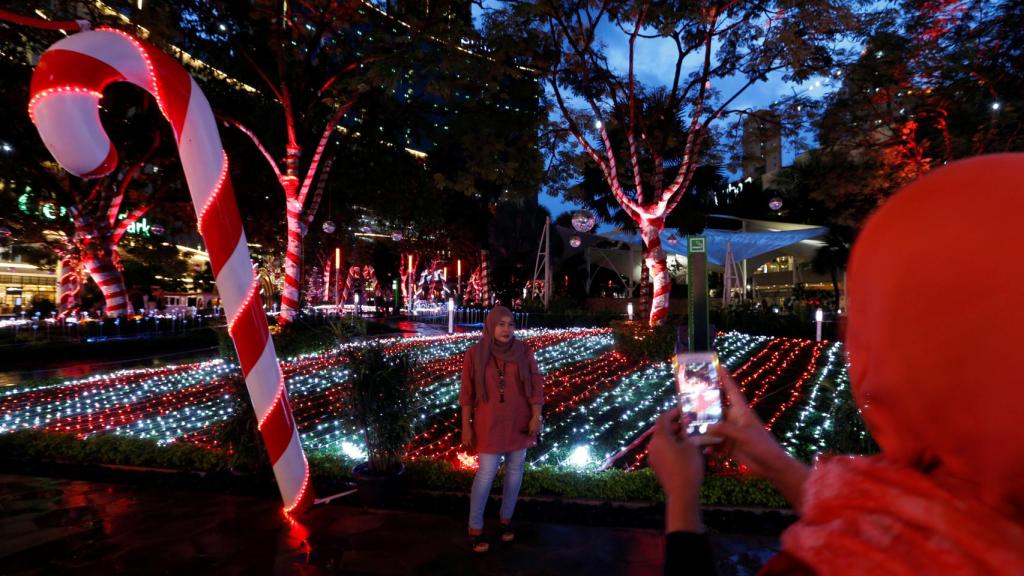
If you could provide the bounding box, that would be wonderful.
[782,154,1024,575]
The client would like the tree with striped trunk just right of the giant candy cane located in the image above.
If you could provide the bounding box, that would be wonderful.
[210,1,370,323]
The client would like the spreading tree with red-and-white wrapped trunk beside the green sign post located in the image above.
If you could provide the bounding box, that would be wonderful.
[513,0,853,325]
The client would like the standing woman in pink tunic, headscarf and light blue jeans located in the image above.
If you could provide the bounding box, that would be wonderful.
[459,306,544,552]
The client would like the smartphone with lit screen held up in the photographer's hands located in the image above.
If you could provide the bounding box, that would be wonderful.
[675,352,722,446]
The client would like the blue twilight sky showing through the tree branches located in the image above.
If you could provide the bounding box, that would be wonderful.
[473,0,838,223]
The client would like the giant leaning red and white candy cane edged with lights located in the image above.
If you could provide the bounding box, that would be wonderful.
[29,30,312,512]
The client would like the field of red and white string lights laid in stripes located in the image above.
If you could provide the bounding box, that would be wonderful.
[0,329,848,469]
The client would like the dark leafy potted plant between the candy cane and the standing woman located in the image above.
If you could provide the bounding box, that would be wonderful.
[347,344,415,506]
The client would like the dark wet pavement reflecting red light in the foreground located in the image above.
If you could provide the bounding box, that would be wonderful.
[0,475,777,575]
